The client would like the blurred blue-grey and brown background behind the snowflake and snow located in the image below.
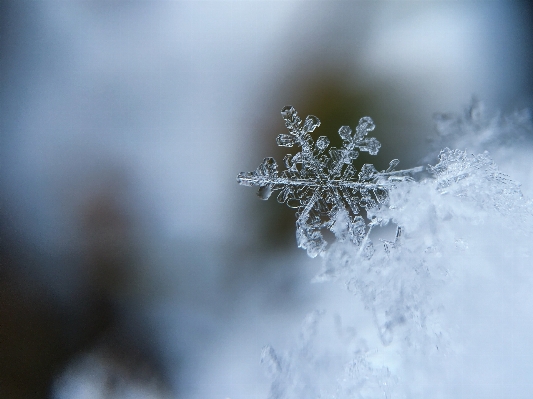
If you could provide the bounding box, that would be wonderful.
[0,0,533,399]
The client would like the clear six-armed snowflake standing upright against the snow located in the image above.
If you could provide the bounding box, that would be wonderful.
[237,105,422,257]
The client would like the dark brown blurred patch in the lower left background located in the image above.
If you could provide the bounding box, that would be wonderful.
[0,173,170,399]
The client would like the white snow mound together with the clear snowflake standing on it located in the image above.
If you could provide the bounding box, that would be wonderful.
[243,107,533,399]
